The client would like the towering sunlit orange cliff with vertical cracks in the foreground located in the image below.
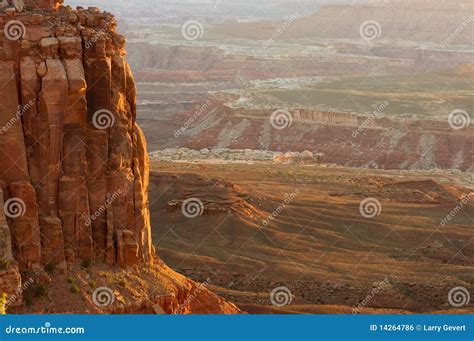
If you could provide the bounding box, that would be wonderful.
[0,0,153,300]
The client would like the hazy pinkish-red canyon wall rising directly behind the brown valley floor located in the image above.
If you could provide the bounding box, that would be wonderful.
[149,102,474,172]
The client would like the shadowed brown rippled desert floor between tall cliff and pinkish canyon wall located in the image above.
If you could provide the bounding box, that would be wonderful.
[150,162,474,314]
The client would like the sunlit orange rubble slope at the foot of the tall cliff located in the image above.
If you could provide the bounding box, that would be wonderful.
[8,259,240,315]
